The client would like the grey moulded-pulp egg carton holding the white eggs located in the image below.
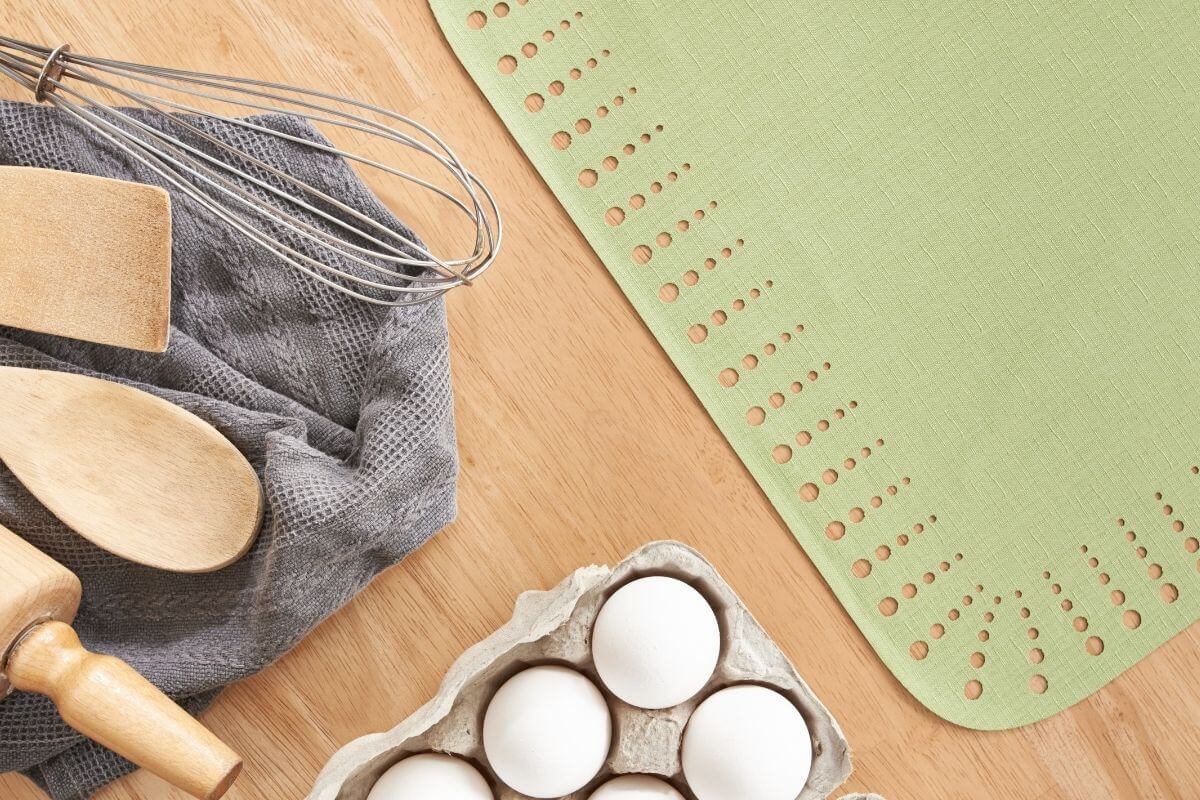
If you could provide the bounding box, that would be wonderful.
[308,542,865,800]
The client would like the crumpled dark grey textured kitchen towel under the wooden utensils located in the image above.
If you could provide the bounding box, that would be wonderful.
[0,102,457,800]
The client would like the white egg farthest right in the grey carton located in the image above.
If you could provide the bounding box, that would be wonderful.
[683,686,812,800]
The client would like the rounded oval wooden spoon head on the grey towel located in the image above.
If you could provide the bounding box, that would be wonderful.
[0,367,263,572]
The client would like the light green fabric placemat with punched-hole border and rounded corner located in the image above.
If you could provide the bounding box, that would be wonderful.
[432,0,1200,728]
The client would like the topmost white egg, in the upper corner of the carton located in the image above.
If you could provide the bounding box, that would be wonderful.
[592,577,721,709]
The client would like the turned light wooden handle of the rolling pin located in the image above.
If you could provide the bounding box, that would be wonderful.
[6,621,241,800]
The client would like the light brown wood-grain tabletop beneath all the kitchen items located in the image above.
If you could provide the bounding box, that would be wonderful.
[0,0,1200,800]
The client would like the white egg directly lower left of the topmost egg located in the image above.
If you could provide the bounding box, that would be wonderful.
[484,667,612,798]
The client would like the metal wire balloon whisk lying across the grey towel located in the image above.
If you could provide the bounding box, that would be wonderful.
[0,36,503,306]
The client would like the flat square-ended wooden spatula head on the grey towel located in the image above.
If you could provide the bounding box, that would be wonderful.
[0,167,170,353]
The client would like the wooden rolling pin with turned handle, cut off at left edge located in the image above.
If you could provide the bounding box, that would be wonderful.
[0,525,241,800]
